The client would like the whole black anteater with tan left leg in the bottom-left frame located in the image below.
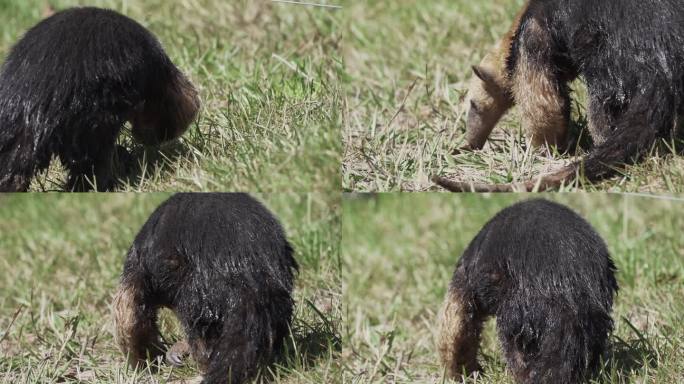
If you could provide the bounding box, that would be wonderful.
[113,194,297,384]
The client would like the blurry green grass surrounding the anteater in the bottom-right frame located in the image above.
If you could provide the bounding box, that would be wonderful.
[342,193,684,384]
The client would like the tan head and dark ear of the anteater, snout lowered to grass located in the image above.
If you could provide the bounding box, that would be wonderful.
[466,58,513,149]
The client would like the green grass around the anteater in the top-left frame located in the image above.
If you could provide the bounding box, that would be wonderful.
[0,0,343,192]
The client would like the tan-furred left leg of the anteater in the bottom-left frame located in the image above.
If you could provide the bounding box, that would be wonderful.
[113,282,163,366]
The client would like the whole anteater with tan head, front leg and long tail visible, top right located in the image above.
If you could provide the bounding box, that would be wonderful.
[433,0,684,191]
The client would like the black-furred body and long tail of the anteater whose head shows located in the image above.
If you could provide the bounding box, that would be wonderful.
[434,0,684,191]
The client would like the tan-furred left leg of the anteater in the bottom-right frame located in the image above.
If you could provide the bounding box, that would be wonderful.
[437,287,481,378]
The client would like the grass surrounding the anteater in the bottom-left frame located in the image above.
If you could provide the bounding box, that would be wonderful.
[0,193,341,383]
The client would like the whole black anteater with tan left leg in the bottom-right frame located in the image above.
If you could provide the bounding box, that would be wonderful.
[438,200,617,384]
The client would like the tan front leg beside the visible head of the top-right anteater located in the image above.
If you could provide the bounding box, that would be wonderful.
[513,19,570,150]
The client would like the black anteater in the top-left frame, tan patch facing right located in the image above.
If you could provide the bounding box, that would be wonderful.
[0,8,199,191]
